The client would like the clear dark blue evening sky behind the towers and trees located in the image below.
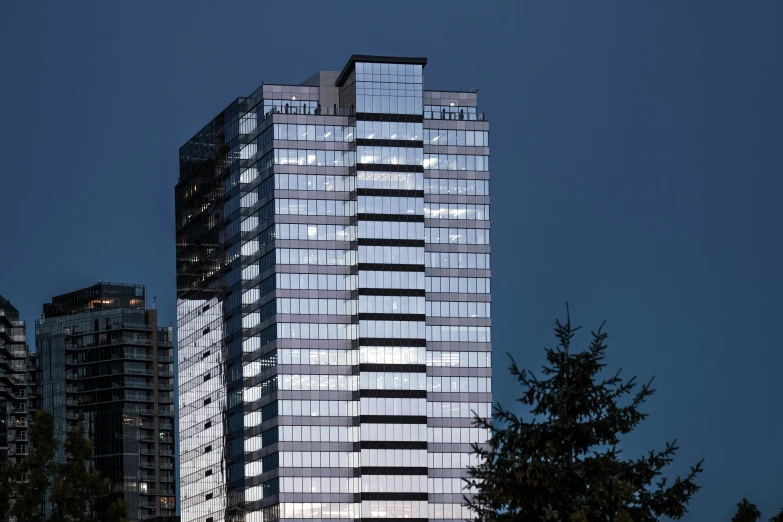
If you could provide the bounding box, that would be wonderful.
[0,0,783,521]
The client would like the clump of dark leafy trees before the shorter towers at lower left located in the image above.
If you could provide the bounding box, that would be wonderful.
[0,410,127,522]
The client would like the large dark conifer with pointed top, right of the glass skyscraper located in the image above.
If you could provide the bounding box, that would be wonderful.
[466,307,702,522]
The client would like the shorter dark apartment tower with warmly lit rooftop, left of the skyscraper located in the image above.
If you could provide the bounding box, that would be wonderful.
[35,282,176,521]
